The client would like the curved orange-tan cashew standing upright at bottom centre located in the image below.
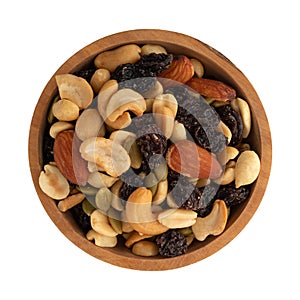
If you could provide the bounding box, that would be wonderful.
[126,187,168,235]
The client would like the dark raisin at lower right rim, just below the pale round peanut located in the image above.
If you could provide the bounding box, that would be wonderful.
[216,182,251,206]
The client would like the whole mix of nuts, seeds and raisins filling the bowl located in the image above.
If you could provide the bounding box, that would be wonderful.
[39,44,260,257]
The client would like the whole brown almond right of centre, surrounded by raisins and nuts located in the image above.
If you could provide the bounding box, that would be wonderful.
[166,140,222,179]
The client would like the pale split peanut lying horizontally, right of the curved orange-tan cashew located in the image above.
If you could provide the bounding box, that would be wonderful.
[158,208,197,228]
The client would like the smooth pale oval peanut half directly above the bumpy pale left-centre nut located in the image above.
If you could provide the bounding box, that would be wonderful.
[75,108,105,141]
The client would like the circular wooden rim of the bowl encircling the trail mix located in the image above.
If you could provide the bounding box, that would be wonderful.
[28,29,272,271]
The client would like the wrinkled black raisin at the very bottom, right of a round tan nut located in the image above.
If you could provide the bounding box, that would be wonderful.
[155,229,187,257]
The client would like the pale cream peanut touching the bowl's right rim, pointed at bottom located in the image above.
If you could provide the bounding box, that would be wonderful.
[235,150,260,188]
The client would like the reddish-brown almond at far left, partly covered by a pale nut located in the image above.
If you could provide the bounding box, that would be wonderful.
[53,130,89,185]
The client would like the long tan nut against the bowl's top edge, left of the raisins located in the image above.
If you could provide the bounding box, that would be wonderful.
[95,44,141,72]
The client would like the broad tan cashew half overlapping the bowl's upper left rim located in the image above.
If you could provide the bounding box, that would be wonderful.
[55,74,94,109]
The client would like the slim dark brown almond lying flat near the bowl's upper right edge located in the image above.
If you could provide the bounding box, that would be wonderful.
[186,77,236,101]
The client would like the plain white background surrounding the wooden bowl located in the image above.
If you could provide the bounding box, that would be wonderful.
[0,0,300,299]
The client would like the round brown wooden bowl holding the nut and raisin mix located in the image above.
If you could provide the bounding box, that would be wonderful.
[29,29,272,270]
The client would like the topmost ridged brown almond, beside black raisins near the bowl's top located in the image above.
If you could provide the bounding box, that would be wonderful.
[159,55,194,86]
